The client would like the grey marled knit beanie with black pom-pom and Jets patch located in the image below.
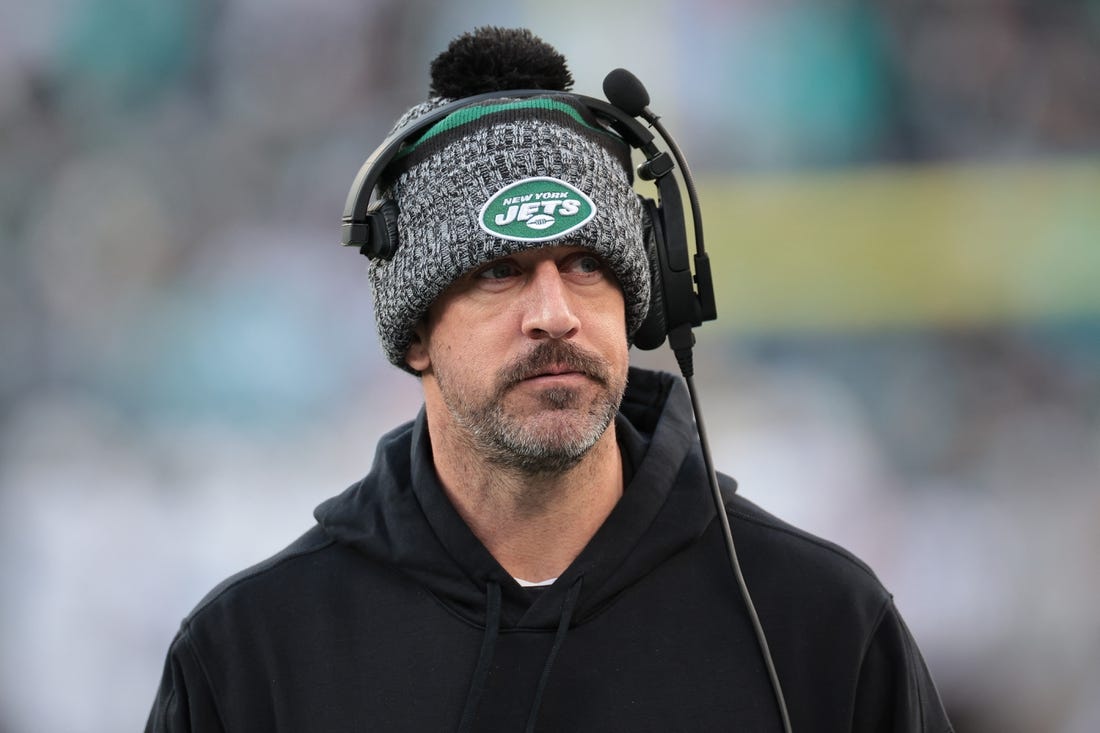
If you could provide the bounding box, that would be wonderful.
[369,28,650,373]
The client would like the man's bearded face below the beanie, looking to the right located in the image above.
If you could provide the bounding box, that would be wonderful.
[407,247,628,474]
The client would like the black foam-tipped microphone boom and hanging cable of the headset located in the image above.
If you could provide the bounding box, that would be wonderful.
[604,68,791,733]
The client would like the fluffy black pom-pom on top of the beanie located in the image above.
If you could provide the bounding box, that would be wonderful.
[430,25,573,99]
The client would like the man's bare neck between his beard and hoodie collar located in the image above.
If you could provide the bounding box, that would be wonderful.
[428,411,623,582]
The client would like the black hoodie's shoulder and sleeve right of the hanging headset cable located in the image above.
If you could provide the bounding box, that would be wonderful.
[725,484,952,733]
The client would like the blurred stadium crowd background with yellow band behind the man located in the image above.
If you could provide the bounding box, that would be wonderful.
[0,0,1100,733]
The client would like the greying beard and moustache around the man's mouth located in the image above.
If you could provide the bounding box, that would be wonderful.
[436,340,626,475]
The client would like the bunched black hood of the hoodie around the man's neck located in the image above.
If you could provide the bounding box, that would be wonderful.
[315,369,715,630]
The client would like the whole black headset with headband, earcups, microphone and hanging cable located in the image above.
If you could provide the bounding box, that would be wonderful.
[342,68,791,733]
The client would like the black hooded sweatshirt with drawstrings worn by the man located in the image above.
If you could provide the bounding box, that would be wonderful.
[146,369,950,733]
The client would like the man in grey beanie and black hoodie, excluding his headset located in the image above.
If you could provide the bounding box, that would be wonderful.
[146,29,950,733]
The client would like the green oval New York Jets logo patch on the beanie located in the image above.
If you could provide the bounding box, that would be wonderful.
[479,177,596,242]
